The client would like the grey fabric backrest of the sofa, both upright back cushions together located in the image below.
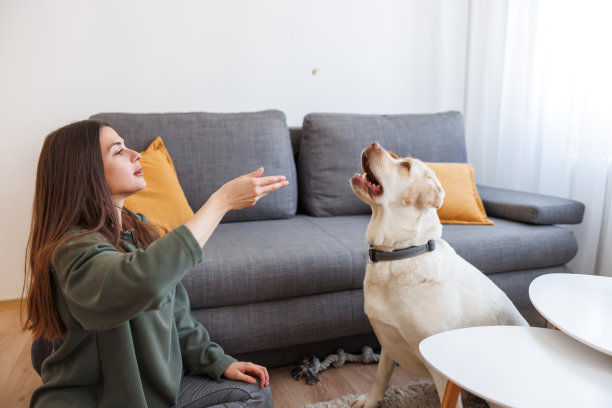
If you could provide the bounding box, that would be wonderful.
[91,110,467,222]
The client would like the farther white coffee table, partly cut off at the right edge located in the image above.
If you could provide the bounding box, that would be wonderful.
[529,273,612,356]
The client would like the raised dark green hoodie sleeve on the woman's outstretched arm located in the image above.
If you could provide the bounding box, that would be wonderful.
[53,225,202,330]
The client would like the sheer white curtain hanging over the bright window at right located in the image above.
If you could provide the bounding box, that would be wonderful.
[465,0,612,276]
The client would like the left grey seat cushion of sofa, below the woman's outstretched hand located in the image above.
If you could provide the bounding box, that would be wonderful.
[183,215,354,309]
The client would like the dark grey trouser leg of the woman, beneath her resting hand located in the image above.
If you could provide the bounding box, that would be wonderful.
[175,375,274,408]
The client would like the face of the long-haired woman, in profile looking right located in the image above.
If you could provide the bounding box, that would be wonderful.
[100,126,147,205]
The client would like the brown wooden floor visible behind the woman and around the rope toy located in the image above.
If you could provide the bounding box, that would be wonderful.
[0,303,415,408]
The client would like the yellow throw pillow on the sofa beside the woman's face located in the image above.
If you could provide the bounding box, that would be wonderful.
[123,137,193,235]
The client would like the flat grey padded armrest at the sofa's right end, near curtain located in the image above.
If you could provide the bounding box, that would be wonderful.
[477,185,584,225]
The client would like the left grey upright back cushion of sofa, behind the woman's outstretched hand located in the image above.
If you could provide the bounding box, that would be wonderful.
[91,110,297,222]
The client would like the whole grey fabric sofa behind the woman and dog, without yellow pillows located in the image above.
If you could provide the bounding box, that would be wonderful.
[33,110,584,368]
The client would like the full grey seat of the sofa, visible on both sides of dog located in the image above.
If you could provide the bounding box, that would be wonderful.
[183,215,577,309]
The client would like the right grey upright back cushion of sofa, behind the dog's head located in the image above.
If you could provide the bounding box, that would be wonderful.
[298,112,466,216]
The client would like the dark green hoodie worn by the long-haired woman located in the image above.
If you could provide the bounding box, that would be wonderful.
[30,214,236,408]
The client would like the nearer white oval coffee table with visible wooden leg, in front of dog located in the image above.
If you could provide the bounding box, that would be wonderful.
[419,326,612,408]
